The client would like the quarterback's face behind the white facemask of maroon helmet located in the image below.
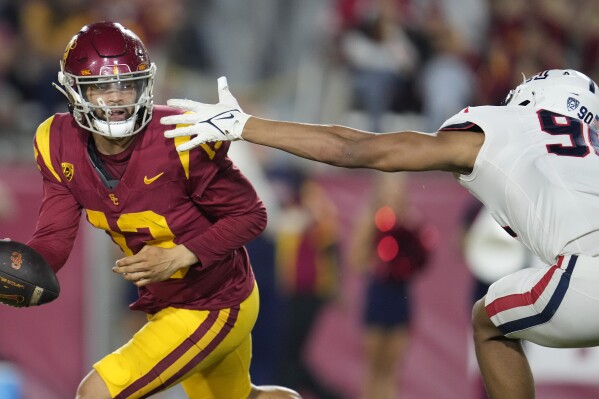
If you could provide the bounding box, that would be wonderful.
[85,82,137,122]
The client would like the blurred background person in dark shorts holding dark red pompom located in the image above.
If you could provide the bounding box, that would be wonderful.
[349,174,432,399]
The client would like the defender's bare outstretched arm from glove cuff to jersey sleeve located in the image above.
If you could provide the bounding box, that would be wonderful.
[243,117,484,174]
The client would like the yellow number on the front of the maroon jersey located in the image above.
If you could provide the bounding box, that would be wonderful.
[86,209,189,278]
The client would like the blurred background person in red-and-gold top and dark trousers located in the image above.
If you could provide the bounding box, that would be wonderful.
[276,173,340,399]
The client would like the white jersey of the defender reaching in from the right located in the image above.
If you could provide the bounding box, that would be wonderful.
[441,106,599,264]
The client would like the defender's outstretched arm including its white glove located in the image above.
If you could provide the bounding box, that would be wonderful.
[161,78,483,173]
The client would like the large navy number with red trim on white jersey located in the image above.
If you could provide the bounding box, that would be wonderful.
[537,109,599,157]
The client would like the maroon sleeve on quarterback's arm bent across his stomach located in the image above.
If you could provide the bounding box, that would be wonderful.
[182,158,267,267]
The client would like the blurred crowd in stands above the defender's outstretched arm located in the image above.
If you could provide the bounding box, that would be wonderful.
[0,0,599,161]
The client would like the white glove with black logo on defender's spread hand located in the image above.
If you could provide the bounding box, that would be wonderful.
[160,76,250,152]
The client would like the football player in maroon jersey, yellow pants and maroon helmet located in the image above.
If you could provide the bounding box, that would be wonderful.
[28,22,299,399]
